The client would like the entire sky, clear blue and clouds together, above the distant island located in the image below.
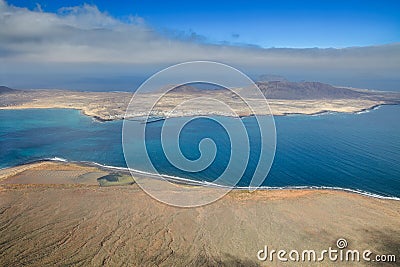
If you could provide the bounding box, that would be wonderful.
[0,0,400,90]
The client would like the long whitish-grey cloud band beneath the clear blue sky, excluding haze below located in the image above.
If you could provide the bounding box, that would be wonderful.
[0,0,400,91]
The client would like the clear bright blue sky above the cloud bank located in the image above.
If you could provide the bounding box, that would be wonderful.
[7,0,400,48]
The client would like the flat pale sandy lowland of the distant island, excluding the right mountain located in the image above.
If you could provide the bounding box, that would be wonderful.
[0,89,400,121]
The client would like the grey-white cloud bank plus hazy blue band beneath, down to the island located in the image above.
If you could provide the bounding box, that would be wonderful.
[0,0,400,90]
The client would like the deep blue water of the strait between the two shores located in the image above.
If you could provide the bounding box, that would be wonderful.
[0,106,400,197]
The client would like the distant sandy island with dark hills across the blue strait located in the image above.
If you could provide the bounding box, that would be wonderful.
[0,81,400,120]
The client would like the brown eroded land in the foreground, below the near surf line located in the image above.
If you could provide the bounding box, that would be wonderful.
[0,161,400,266]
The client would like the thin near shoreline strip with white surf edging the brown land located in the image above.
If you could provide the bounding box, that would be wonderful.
[0,157,400,201]
